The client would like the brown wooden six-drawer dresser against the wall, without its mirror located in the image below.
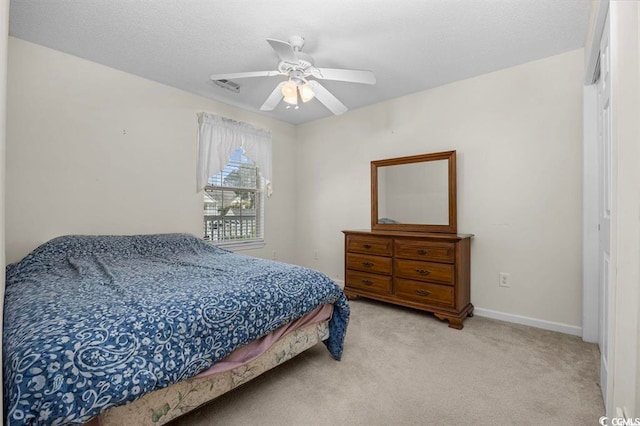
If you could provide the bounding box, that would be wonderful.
[342,230,473,329]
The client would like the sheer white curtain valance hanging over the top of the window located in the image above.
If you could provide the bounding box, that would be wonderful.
[197,112,271,195]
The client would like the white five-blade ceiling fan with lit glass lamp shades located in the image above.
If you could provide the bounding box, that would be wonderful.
[211,36,376,115]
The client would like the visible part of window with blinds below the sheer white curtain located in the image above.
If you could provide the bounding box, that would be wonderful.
[204,148,264,249]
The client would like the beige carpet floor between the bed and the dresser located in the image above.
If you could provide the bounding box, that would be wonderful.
[172,299,604,426]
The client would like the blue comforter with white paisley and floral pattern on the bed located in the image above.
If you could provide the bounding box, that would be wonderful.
[3,234,349,425]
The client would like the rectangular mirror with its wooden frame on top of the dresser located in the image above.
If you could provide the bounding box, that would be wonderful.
[371,151,457,233]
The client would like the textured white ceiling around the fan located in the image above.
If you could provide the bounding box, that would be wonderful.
[10,0,590,124]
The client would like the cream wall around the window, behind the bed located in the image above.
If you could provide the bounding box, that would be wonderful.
[6,37,295,262]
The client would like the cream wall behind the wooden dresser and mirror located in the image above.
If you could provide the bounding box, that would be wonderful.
[297,49,583,333]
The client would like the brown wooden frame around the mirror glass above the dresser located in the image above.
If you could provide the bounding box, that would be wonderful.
[371,151,458,234]
